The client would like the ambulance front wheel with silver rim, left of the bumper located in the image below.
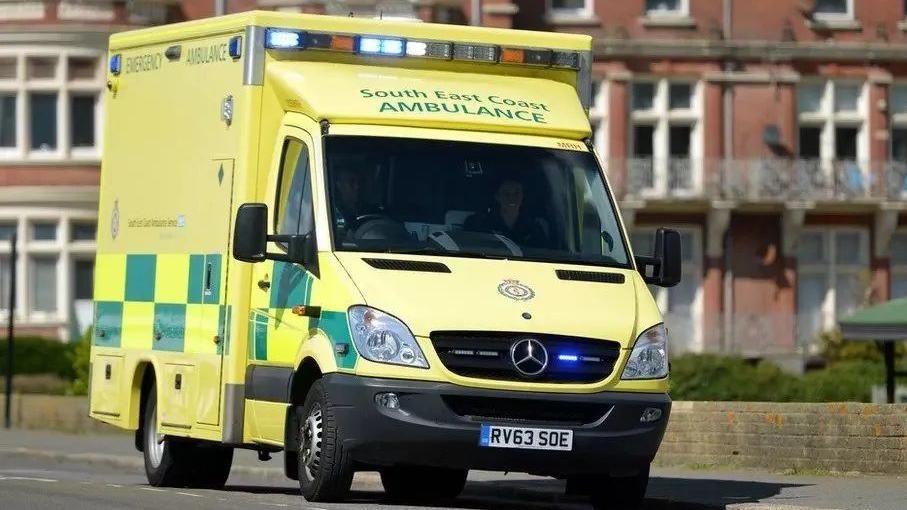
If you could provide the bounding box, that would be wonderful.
[297,381,354,502]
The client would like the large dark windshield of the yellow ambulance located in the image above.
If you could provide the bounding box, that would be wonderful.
[325,136,629,267]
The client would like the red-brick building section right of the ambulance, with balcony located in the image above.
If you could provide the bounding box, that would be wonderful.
[516,0,907,365]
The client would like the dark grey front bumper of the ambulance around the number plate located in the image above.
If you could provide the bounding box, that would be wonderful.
[322,374,671,476]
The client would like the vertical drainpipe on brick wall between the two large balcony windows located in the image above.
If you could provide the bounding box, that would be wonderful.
[719,0,734,351]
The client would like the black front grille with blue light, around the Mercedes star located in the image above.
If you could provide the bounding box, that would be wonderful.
[431,331,620,383]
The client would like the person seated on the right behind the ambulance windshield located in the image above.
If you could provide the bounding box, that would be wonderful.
[463,176,549,248]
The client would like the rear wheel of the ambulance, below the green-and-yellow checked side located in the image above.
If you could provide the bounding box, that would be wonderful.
[142,388,233,489]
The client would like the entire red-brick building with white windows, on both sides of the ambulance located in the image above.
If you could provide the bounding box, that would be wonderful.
[7,0,907,365]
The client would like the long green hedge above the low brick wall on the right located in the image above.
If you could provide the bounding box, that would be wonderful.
[671,354,885,402]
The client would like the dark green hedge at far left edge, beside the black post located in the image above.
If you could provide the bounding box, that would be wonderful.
[0,336,75,379]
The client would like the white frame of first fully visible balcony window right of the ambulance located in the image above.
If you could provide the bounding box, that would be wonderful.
[627,76,705,198]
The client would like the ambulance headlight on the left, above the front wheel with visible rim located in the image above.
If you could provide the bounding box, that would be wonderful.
[349,306,428,368]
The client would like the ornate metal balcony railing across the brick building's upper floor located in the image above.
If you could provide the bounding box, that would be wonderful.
[605,158,907,202]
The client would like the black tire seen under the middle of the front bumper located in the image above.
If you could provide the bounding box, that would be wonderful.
[381,466,469,503]
